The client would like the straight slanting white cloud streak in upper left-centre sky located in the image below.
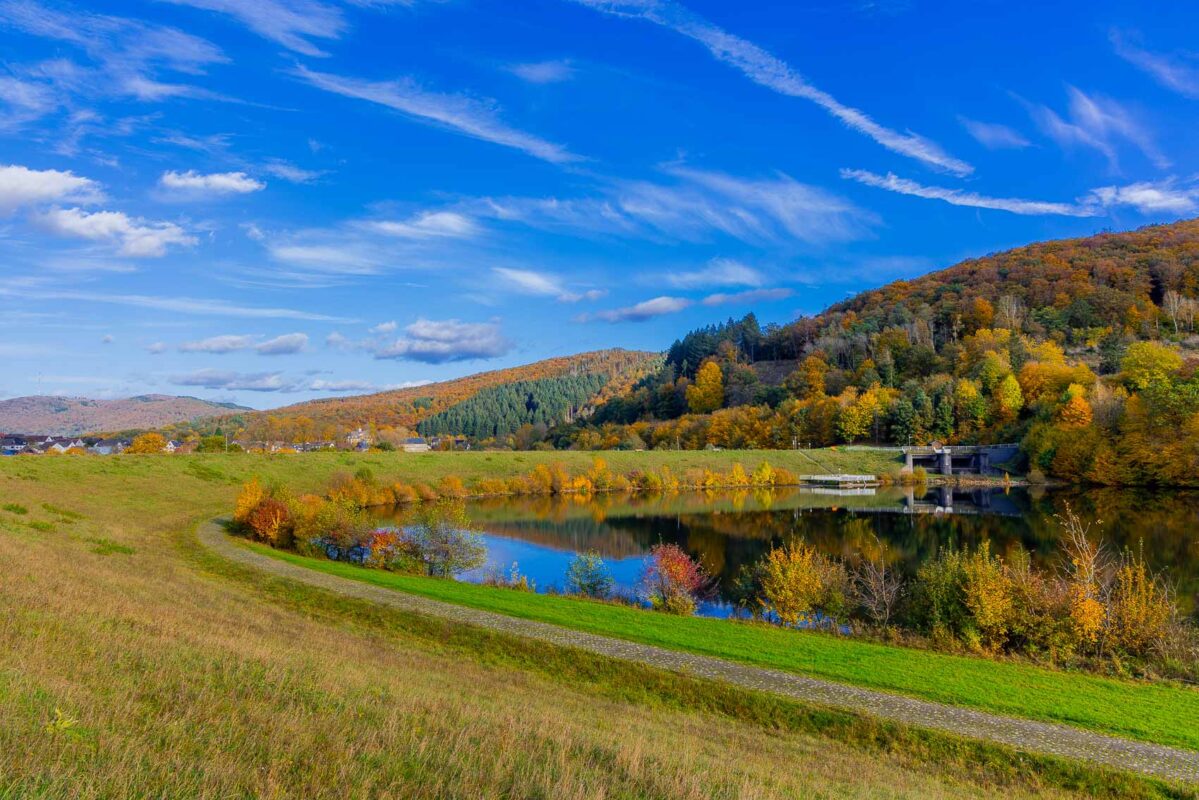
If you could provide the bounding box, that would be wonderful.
[295,66,578,163]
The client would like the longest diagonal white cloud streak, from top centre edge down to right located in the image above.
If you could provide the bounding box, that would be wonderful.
[565,0,974,175]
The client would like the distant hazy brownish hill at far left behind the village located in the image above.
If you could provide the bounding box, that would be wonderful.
[0,395,240,437]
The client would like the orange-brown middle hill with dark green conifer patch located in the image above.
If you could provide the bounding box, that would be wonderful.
[219,349,662,440]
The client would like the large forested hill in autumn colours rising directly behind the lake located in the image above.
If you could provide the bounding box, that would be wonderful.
[563,219,1199,486]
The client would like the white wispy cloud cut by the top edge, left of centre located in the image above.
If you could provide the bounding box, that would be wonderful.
[159,0,347,56]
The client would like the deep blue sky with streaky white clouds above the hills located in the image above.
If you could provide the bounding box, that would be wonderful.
[0,0,1199,408]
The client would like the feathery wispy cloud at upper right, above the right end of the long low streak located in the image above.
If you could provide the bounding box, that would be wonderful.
[1028,86,1170,169]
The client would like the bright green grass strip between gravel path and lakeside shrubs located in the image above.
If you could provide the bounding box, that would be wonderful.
[246,542,1199,750]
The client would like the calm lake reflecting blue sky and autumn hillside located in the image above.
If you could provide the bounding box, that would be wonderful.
[364,487,1199,616]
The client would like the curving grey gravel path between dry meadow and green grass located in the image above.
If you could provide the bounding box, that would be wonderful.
[199,522,1199,783]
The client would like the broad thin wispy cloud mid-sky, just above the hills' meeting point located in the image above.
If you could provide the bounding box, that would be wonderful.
[472,166,874,245]
